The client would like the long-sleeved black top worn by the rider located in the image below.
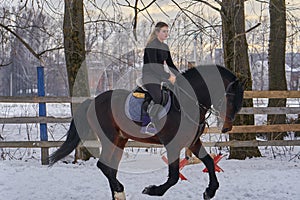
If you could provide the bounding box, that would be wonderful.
[143,38,178,81]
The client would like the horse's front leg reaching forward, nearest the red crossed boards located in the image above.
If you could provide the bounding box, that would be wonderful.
[189,139,219,200]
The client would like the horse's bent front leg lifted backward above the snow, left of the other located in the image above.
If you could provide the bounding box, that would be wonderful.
[143,152,179,196]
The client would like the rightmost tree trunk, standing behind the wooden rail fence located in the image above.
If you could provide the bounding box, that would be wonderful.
[268,0,287,140]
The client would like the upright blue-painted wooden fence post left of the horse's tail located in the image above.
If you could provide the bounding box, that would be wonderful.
[37,66,49,165]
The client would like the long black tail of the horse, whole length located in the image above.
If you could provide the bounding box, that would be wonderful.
[48,99,92,167]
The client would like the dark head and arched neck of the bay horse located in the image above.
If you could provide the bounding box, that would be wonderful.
[178,65,244,133]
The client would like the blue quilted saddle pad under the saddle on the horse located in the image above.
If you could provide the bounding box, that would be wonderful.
[125,93,171,122]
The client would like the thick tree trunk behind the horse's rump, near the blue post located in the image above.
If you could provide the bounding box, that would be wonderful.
[63,0,91,160]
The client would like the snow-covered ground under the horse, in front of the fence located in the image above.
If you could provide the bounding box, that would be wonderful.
[0,149,300,200]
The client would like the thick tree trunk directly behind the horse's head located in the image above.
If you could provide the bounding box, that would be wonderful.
[221,0,261,159]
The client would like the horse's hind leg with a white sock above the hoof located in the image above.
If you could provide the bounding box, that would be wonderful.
[97,135,127,200]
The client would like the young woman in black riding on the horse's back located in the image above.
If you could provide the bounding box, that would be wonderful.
[141,22,179,135]
